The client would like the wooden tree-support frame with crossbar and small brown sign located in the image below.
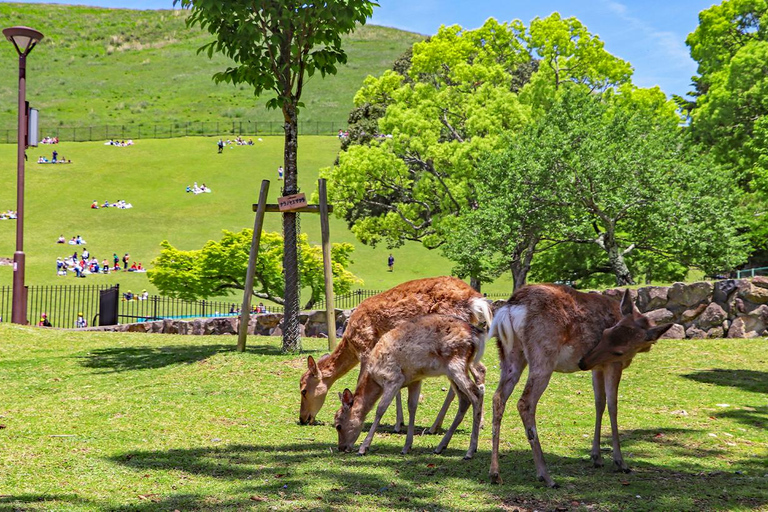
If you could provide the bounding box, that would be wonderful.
[237,179,336,352]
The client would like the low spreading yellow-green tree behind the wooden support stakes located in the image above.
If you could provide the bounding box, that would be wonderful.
[148,229,360,309]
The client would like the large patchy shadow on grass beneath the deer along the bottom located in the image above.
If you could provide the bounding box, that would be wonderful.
[106,429,768,511]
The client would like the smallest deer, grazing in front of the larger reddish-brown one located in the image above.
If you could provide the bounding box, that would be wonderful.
[334,315,485,459]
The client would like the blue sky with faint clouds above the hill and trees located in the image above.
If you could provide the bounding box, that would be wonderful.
[0,0,719,95]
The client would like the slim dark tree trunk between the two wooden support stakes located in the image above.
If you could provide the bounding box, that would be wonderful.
[283,105,301,352]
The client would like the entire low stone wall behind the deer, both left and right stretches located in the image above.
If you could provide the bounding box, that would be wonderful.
[88,276,768,339]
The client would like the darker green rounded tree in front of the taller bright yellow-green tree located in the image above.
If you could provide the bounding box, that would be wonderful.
[470,85,745,285]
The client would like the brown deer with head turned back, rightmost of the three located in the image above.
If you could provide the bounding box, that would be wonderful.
[488,285,671,487]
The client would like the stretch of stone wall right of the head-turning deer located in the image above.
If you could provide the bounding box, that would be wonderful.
[603,276,768,339]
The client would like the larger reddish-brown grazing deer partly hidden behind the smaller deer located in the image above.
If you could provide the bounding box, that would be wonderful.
[299,276,492,433]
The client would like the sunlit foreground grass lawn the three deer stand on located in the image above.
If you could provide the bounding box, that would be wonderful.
[0,325,768,511]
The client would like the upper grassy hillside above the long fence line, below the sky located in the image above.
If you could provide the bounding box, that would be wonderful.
[0,3,422,131]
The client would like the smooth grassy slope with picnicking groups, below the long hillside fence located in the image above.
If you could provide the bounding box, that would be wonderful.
[0,136,512,297]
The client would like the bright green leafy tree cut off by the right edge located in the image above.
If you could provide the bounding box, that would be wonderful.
[686,0,768,262]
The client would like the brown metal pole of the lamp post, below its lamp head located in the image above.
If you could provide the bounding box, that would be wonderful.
[11,55,27,325]
